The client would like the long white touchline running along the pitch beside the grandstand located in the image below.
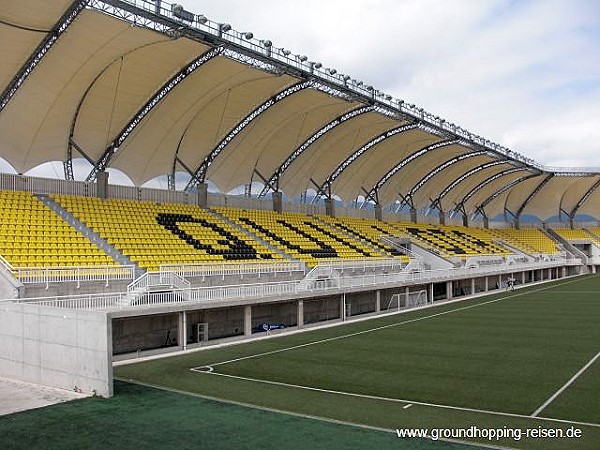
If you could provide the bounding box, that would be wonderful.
[190,280,579,372]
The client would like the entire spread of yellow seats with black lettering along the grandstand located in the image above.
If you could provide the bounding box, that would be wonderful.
[0,191,580,270]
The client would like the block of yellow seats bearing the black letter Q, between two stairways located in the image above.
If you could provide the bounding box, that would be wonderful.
[54,196,282,270]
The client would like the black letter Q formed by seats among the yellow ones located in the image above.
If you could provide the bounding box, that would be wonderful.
[156,213,258,260]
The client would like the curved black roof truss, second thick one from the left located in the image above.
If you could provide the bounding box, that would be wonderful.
[86,47,224,181]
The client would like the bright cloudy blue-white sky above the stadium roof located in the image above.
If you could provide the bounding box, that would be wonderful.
[0,0,600,185]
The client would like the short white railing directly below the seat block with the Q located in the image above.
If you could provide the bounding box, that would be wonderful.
[160,261,306,278]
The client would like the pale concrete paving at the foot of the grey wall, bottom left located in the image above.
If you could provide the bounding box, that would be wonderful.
[0,378,88,416]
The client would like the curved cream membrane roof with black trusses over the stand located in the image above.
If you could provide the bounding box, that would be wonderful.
[0,0,600,219]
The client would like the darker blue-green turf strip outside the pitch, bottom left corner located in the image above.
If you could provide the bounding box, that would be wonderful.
[0,382,466,450]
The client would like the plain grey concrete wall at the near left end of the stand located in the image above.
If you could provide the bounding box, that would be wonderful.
[0,301,113,397]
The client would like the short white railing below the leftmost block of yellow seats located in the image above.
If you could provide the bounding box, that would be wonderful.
[11,265,135,287]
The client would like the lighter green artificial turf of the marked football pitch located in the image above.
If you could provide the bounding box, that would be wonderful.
[115,277,600,449]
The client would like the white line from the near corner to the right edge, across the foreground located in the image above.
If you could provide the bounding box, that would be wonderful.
[197,371,600,428]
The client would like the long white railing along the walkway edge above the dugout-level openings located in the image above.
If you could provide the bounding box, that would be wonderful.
[11,260,576,310]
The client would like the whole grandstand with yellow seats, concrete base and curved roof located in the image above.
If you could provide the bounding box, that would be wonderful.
[0,0,600,442]
